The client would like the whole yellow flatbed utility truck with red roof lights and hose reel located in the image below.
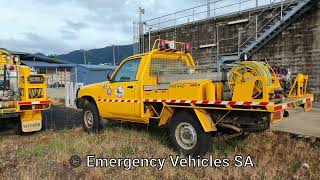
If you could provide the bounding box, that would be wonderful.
[77,40,313,156]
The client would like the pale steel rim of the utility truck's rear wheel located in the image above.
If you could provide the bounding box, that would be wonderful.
[175,122,197,150]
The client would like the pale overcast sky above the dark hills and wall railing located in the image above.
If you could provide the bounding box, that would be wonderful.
[0,0,206,54]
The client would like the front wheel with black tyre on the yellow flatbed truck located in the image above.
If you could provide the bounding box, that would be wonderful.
[81,102,101,133]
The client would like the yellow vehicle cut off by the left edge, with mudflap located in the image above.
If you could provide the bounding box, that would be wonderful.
[0,50,51,133]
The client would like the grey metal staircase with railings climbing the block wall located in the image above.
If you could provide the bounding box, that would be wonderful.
[219,0,320,61]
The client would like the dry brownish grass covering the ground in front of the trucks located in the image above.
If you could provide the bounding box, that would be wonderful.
[0,124,320,179]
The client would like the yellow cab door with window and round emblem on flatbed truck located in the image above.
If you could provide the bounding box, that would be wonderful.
[105,59,141,119]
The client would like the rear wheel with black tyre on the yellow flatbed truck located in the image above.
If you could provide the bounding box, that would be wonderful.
[169,111,212,157]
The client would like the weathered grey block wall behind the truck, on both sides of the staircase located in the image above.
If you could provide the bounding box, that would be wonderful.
[145,3,320,97]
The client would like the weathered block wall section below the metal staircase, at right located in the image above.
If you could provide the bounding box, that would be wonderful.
[254,4,320,93]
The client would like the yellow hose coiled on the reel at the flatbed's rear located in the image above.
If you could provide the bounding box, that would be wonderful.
[228,61,273,99]
